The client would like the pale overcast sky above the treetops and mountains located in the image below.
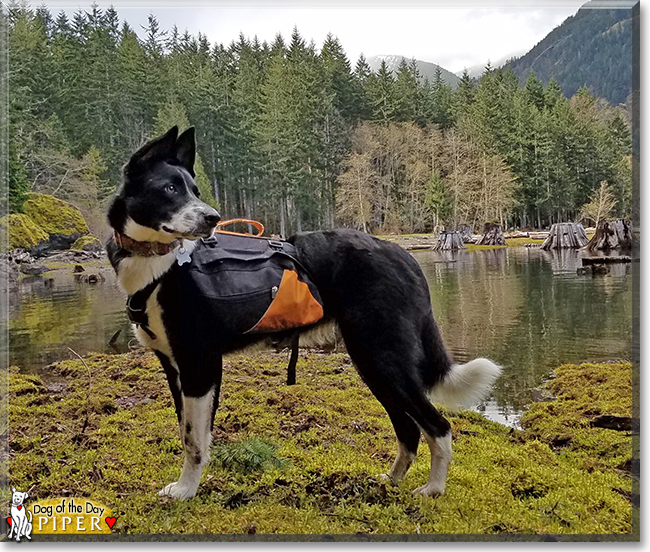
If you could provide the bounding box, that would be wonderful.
[39,0,631,72]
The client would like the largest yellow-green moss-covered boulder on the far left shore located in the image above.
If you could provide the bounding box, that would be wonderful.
[23,194,88,236]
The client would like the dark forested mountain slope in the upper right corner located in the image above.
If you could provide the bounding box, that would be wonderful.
[504,1,632,105]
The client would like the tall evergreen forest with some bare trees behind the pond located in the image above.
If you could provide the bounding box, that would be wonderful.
[2,4,632,237]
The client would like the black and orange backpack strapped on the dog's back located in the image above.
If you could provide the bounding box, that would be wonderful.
[178,222,323,340]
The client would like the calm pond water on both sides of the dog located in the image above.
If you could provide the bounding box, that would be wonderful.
[4,247,638,425]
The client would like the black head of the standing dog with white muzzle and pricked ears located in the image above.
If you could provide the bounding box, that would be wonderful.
[108,126,221,243]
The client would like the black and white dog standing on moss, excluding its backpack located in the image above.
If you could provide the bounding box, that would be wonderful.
[107,127,501,499]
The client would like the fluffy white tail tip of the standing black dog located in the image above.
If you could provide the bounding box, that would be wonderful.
[429,358,501,410]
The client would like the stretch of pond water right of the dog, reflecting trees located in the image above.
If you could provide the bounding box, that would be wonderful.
[417,247,632,424]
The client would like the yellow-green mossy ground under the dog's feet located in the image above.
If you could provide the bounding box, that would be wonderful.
[3,351,632,534]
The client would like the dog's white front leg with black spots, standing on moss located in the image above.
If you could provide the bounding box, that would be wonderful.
[158,358,221,500]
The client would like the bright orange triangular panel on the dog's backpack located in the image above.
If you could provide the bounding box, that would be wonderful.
[249,270,323,332]
